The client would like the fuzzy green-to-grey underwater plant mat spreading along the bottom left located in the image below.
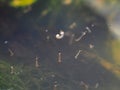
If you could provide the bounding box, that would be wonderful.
[0,61,86,90]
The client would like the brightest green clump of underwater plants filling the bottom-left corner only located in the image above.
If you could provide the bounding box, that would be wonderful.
[0,61,25,90]
